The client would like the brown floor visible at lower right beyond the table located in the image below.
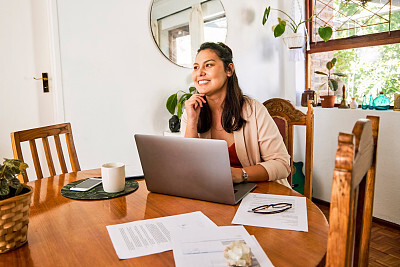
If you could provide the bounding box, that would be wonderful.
[316,203,400,267]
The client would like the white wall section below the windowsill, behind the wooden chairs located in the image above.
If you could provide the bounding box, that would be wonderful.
[293,107,400,224]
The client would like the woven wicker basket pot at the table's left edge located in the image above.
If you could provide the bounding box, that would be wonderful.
[0,185,33,253]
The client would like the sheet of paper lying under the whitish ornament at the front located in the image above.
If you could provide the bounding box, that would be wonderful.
[171,226,273,267]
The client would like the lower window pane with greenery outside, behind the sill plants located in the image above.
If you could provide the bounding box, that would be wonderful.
[311,43,400,105]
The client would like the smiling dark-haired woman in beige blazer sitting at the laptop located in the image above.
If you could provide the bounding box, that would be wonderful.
[181,43,290,187]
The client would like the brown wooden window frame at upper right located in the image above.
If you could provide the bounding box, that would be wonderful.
[305,0,400,88]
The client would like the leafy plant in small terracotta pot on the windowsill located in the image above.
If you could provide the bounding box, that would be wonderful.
[315,58,347,108]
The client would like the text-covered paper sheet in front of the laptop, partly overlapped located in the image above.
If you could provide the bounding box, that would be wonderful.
[107,211,217,259]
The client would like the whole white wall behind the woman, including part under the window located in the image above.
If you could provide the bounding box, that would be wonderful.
[53,0,400,224]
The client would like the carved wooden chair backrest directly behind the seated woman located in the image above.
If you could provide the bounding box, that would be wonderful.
[264,98,314,199]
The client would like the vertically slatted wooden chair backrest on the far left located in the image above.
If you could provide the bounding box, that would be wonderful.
[11,123,81,183]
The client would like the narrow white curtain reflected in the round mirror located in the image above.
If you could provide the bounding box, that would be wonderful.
[189,3,204,62]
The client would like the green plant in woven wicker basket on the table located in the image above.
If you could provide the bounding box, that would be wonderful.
[0,159,32,253]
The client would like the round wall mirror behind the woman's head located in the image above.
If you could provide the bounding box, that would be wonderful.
[150,0,227,68]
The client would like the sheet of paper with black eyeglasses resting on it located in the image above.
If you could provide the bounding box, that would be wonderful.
[232,193,308,232]
